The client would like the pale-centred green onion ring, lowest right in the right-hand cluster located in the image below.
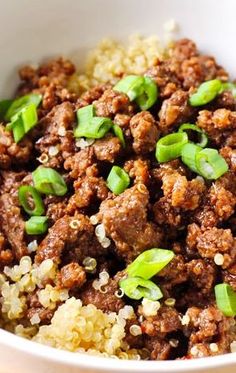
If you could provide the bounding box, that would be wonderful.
[196,148,228,180]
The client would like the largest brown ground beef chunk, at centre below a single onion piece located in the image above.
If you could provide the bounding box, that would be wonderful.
[100,185,162,261]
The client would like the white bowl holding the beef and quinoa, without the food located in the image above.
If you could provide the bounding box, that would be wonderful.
[0,0,236,373]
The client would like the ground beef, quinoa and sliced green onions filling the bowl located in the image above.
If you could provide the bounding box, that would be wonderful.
[0,39,236,360]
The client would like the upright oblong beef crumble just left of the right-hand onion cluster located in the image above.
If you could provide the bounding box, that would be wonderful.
[130,111,158,154]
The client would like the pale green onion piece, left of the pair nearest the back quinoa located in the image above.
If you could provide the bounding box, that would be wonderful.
[113,75,144,101]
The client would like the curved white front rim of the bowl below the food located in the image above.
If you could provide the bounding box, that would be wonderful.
[0,329,236,373]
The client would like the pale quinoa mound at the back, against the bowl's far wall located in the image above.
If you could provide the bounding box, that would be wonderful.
[69,33,168,92]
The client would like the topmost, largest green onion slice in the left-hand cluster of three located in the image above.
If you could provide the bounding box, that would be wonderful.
[32,166,67,196]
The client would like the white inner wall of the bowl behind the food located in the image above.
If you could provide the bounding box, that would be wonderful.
[0,0,236,98]
